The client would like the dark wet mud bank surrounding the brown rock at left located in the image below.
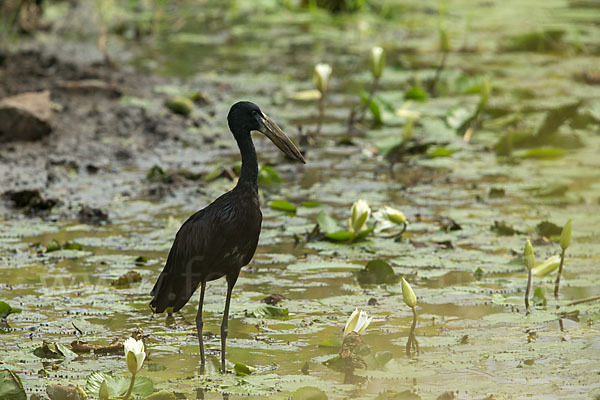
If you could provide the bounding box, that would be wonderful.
[0,45,227,215]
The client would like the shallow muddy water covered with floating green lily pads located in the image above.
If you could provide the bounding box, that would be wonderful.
[0,1,600,399]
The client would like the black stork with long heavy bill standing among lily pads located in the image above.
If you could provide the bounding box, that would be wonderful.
[150,101,306,372]
